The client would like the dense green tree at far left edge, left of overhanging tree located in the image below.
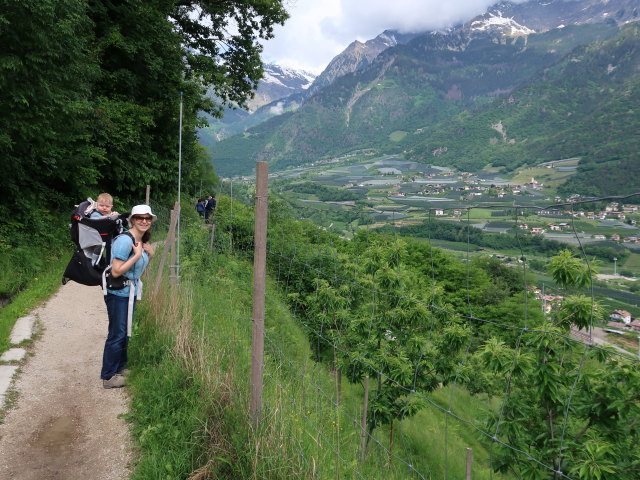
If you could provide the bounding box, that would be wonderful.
[0,0,100,227]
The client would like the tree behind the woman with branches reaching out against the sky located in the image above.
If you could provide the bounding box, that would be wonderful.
[88,0,287,203]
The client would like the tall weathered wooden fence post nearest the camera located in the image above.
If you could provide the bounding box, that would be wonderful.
[251,162,269,424]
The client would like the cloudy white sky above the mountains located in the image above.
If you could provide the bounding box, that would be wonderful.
[263,0,524,74]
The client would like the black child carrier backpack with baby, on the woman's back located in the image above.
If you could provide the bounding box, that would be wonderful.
[62,198,129,285]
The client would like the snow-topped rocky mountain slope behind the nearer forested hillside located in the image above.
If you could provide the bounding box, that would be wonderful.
[215,0,638,197]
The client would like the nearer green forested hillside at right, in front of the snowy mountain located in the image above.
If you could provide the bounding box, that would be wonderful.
[409,23,640,195]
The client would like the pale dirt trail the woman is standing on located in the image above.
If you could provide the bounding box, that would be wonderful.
[0,282,131,480]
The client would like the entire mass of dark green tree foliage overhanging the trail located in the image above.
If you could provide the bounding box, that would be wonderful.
[0,0,287,248]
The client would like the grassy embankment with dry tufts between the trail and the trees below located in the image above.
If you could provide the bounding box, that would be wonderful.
[129,206,505,479]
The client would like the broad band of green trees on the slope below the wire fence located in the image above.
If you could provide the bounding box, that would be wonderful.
[212,198,640,480]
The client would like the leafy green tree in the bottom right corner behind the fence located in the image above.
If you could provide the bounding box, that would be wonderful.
[473,324,640,480]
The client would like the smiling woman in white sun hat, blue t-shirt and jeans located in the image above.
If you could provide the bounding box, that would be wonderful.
[100,205,157,388]
